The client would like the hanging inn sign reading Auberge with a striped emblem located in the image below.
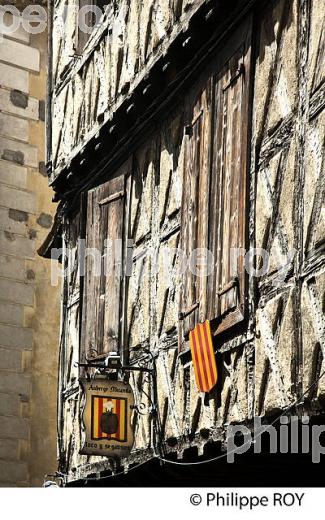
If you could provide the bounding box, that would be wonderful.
[80,378,134,458]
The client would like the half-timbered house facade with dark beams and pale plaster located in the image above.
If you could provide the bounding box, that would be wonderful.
[44,0,325,481]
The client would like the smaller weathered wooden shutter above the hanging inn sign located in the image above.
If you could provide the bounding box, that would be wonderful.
[82,168,126,359]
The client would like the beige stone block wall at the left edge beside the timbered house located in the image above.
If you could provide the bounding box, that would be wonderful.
[0,7,59,486]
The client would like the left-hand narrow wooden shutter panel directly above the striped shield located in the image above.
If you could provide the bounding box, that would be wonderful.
[179,80,212,337]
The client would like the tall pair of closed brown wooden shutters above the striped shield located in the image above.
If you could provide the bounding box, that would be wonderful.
[179,16,251,345]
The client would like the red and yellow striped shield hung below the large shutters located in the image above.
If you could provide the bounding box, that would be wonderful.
[190,320,218,392]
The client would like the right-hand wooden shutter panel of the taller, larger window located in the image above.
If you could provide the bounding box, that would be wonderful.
[208,20,251,333]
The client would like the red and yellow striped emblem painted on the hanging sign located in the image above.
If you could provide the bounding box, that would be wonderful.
[91,395,127,442]
